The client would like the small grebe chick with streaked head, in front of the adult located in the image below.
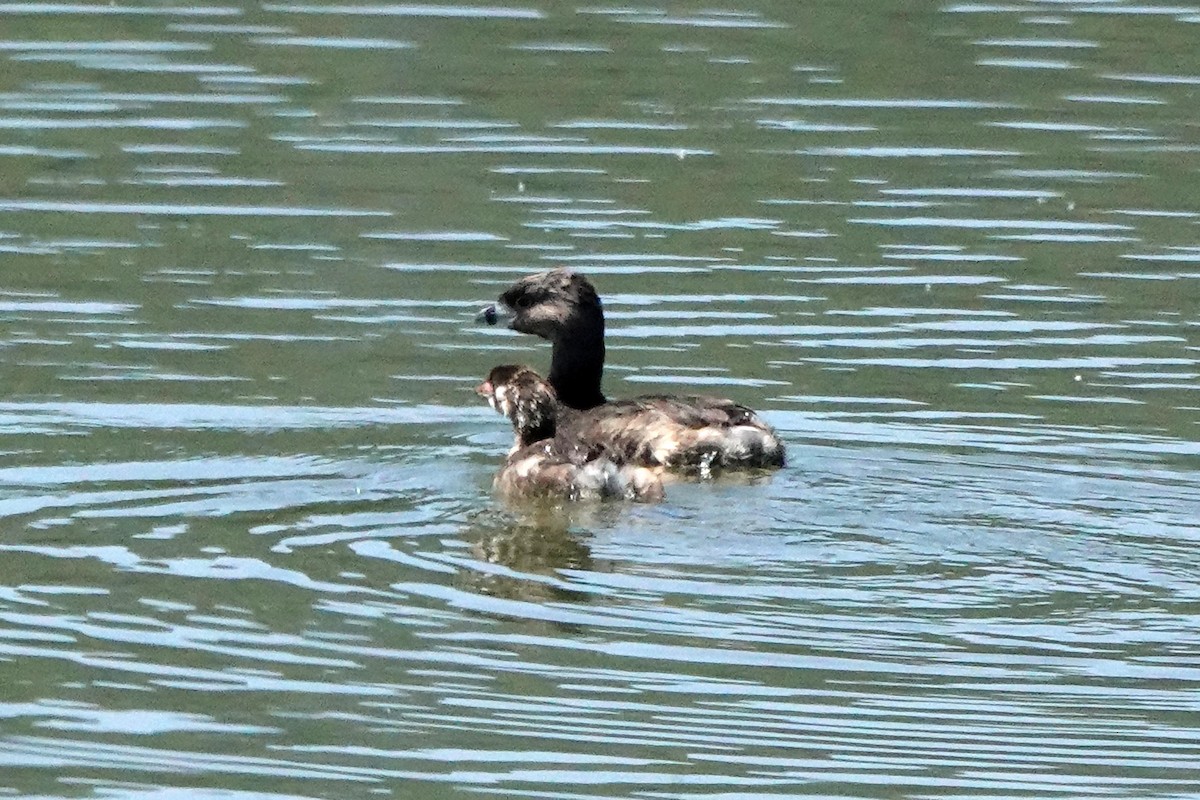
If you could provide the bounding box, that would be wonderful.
[475,365,662,500]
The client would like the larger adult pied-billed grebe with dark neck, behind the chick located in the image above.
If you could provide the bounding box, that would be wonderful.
[480,269,784,471]
